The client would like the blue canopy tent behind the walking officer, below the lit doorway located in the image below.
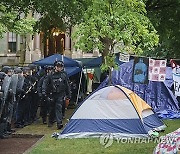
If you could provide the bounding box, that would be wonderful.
[33,54,82,76]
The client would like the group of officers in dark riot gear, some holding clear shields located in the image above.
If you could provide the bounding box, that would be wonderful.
[0,61,71,138]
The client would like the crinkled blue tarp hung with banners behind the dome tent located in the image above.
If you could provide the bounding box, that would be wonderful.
[99,60,180,119]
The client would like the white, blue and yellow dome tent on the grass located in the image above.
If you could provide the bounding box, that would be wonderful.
[59,86,166,138]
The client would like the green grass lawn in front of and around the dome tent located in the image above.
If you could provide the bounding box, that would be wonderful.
[17,111,180,154]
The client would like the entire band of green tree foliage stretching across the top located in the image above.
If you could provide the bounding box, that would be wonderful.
[0,0,180,58]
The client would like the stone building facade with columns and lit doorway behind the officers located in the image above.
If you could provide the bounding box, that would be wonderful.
[0,32,72,65]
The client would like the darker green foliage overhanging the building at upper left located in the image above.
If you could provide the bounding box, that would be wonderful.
[2,0,88,33]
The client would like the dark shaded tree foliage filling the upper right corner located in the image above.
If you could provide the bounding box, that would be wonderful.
[144,0,180,58]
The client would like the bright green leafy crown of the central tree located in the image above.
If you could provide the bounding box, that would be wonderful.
[75,0,158,56]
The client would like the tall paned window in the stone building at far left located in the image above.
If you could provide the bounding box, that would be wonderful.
[8,32,17,53]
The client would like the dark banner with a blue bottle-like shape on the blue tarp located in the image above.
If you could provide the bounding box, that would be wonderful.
[132,57,149,84]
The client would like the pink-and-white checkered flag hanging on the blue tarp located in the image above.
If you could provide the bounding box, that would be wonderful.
[149,59,166,82]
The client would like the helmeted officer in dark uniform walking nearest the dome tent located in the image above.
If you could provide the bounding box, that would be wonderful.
[42,61,71,129]
